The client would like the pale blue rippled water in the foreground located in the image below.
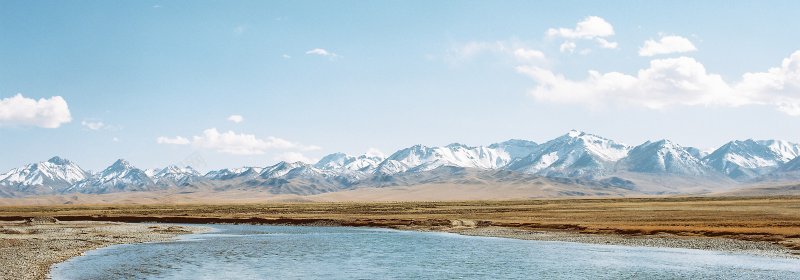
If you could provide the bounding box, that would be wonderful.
[51,225,800,279]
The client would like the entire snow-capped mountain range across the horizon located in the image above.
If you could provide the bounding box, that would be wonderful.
[0,130,800,197]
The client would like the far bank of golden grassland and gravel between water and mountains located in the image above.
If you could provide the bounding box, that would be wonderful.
[0,196,800,274]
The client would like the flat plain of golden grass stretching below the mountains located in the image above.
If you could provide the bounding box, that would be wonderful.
[0,196,800,249]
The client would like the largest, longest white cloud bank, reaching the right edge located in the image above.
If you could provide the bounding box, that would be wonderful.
[517,51,800,116]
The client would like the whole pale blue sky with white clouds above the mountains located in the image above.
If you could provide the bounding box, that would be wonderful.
[0,0,800,172]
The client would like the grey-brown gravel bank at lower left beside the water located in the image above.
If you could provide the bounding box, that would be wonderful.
[0,217,204,280]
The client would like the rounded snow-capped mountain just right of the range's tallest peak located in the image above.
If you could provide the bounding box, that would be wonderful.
[617,140,712,176]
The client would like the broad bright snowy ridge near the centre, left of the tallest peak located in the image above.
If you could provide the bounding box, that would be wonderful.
[375,143,511,174]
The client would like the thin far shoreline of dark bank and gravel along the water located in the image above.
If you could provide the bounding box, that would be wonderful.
[0,216,800,258]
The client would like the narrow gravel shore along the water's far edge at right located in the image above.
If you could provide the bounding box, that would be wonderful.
[432,227,800,258]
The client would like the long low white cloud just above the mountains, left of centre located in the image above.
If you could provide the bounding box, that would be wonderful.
[156,128,322,155]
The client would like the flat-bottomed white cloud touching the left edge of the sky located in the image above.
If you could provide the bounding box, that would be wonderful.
[0,94,72,128]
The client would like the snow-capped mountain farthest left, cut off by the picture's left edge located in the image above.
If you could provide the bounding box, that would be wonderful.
[0,157,89,193]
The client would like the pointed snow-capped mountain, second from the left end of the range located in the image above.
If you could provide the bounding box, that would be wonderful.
[65,159,155,193]
